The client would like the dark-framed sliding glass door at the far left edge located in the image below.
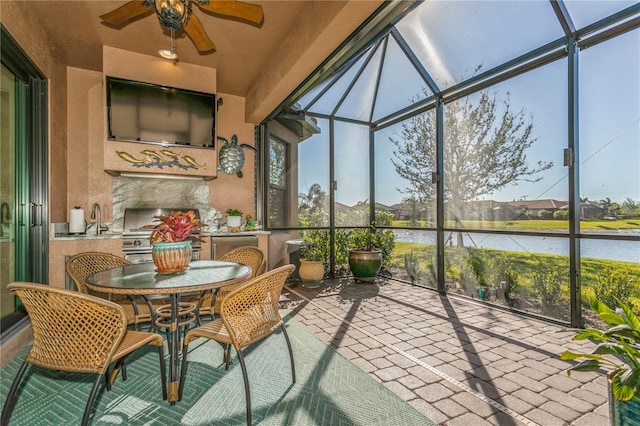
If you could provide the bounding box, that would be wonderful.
[0,26,48,334]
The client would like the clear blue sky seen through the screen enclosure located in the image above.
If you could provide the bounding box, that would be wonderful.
[299,0,640,205]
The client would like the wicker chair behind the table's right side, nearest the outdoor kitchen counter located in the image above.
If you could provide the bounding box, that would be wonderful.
[192,246,267,319]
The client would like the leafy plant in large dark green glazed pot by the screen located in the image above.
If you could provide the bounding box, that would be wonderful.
[347,225,395,282]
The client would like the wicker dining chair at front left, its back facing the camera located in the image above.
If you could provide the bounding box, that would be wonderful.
[1,282,167,425]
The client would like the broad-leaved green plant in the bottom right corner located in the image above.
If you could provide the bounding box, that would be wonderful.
[560,298,640,425]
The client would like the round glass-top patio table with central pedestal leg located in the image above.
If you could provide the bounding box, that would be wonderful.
[85,260,251,404]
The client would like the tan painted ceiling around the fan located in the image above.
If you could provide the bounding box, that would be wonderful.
[25,0,381,96]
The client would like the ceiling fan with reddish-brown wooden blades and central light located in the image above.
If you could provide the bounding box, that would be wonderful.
[100,0,264,53]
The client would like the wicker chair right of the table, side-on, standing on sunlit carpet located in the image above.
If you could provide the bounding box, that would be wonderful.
[178,265,296,425]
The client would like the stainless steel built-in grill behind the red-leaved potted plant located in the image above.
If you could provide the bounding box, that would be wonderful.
[122,208,201,263]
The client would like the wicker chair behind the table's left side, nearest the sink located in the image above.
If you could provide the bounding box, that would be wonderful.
[65,252,166,327]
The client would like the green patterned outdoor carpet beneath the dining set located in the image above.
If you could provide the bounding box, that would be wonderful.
[0,317,434,426]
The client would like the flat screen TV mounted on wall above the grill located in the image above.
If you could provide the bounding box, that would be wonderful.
[107,77,216,148]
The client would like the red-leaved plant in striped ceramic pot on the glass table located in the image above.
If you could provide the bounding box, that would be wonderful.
[145,210,202,274]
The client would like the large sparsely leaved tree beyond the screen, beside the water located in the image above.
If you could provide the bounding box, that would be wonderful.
[390,91,553,220]
